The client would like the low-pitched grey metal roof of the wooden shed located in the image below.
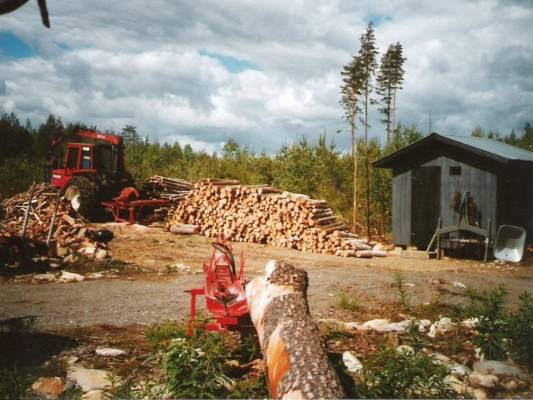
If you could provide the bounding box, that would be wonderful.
[372,132,533,168]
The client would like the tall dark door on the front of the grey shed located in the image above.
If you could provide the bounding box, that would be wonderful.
[411,167,441,250]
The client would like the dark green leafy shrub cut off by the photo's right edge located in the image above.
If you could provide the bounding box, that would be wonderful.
[508,292,533,367]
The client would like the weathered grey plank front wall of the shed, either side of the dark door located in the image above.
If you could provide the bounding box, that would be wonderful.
[392,156,498,246]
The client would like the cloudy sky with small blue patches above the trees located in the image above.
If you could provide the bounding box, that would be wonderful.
[0,0,533,152]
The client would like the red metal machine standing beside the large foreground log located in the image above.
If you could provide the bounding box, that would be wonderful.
[187,238,249,335]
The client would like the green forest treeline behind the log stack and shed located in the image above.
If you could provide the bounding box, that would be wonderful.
[0,113,533,234]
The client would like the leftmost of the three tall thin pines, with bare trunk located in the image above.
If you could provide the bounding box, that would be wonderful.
[341,56,363,232]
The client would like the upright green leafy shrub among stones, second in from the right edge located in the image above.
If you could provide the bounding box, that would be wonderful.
[467,285,510,360]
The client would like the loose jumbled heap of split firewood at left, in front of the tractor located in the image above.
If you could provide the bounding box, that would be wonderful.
[0,183,108,259]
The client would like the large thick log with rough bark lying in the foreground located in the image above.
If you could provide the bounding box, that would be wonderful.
[246,261,344,399]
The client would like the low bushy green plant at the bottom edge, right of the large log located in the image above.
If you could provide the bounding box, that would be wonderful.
[357,347,457,399]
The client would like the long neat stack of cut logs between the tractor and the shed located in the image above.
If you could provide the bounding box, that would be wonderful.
[169,179,384,257]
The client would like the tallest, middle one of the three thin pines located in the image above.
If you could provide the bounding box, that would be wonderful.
[359,23,378,240]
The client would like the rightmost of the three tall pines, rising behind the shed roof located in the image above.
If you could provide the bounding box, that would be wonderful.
[377,42,406,144]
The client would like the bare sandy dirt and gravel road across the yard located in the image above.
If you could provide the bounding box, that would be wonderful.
[0,225,533,330]
